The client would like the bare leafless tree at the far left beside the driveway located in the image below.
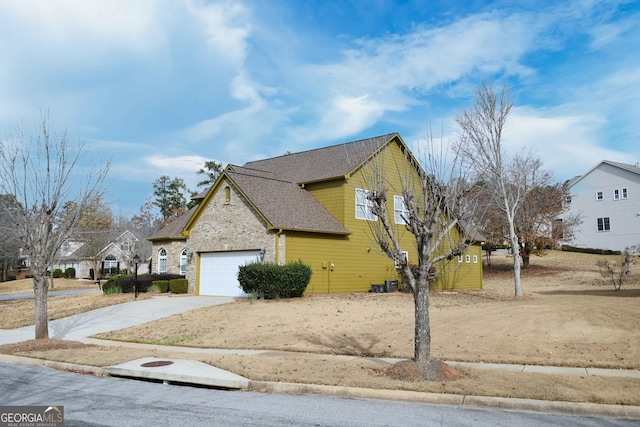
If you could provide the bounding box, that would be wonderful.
[0,114,109,339]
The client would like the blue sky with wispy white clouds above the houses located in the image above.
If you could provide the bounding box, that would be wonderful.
[0,0,640,216]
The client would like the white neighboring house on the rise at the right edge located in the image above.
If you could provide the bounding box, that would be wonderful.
[567,160,640,250]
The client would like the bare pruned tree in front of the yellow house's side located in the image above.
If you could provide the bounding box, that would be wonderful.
[363,133,475,374]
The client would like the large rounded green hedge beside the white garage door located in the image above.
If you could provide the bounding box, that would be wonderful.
[238,261,313,299]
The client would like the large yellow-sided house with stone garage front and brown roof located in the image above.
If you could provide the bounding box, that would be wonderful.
[150,133,482,296]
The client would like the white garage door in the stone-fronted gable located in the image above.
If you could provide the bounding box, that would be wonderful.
[200,251,260,297]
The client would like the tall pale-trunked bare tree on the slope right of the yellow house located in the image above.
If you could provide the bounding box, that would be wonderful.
[456,82,541,297]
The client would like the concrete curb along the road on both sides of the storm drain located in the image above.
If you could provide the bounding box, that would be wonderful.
[0,354,640,420]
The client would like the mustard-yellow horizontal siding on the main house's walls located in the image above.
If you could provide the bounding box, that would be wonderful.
[285,140,482,293]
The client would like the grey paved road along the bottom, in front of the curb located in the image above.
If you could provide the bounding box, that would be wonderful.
[0,363,637,427]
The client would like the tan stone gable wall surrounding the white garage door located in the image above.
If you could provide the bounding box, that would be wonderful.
[187,181,276,292]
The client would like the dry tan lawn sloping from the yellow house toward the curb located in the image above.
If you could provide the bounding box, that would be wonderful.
[3,251,640,405]
